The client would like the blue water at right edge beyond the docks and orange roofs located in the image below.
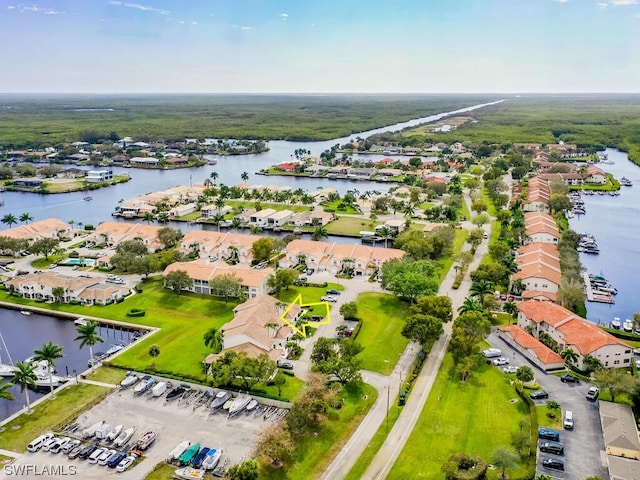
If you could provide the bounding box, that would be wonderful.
[570,149,640,322]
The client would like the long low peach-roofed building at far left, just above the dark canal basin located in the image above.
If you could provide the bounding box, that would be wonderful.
[5,271,130,305]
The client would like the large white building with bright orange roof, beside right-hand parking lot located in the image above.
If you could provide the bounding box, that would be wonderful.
[518,300,633,370]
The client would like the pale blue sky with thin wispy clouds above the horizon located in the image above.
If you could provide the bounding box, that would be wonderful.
[0,0,640,93]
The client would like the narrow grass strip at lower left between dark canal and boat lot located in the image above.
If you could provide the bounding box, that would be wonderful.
[0,383,112,452]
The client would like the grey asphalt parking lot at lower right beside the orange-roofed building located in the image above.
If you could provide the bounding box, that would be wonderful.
[488,332,609,480]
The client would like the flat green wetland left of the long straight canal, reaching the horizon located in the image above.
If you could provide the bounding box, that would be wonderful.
[0,95,496,147]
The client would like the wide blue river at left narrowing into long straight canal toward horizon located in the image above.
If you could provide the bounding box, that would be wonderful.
[0,102,496,225]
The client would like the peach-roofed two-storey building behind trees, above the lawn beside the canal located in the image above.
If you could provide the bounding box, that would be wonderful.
[162,258,274,298]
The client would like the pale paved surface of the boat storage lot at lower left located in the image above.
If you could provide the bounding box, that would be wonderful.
[0,389,271,480]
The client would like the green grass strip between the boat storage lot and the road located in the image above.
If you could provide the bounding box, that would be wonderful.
[260,385,377,480]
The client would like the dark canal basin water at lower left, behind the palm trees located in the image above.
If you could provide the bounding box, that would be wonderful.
[0,309,136,419]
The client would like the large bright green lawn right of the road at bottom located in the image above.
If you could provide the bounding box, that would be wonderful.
[389,354,528,479]
